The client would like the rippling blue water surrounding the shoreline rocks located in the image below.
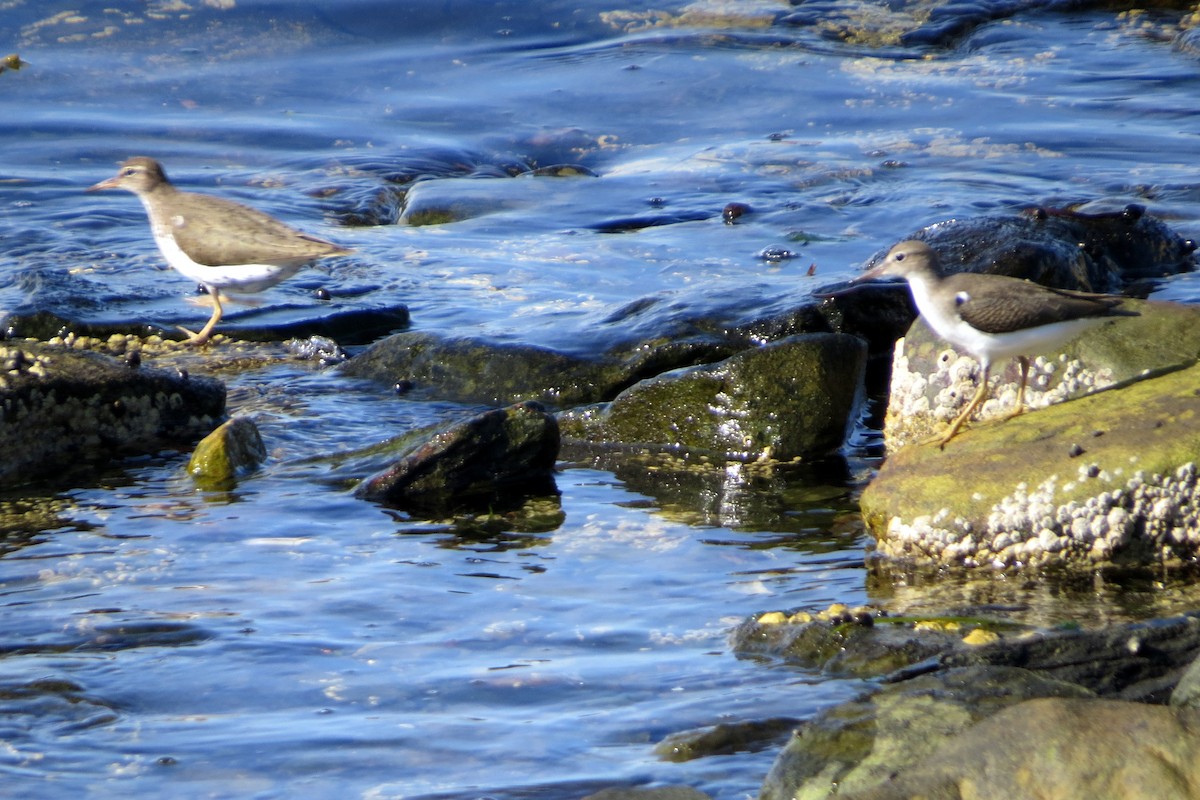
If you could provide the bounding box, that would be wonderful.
[7,0,1200,798]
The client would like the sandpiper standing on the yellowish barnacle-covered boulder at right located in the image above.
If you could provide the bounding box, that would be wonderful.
[853,241,1138,447]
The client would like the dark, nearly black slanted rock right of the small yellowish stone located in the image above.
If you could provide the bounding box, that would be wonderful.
[355,403,559,511]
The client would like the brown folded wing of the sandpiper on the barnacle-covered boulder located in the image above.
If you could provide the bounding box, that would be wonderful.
[942,275,1134,333]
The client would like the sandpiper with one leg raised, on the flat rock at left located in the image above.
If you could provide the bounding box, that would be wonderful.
[88,156,350,344]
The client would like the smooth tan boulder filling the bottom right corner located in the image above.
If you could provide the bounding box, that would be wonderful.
[838,697,1200,800]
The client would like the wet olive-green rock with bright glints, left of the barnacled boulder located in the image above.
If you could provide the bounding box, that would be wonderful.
[562,333,866,461]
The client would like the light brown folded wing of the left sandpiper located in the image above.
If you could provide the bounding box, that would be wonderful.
[170,192,349,266]
